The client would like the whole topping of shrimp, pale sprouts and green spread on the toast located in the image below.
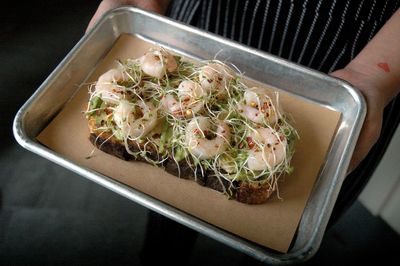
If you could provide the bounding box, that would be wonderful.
[86,48,298,202]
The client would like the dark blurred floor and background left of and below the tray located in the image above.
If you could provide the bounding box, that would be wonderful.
[0,0,400,265]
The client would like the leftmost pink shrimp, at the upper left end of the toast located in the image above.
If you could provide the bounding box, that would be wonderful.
[94,68,129,104]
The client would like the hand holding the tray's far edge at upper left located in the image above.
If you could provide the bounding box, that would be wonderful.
[86,0,170,32]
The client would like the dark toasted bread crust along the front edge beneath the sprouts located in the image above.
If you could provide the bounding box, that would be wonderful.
[89,129,273,204]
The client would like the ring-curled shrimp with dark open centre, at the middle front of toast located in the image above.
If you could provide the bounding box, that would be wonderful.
[185,116,231,160]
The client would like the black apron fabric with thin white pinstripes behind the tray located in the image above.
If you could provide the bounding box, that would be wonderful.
[169,0,400,73]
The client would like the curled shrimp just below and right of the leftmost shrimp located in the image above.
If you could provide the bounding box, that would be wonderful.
[113,100,158,139]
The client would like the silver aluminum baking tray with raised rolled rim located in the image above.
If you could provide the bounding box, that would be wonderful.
[13,7,366,264]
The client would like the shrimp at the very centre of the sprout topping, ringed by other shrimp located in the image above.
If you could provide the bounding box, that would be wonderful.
[162,80,207,118]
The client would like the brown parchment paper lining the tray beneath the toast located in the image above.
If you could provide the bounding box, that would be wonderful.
[37,35,340,252]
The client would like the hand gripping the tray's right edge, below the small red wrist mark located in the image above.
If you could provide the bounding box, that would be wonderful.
[330,66,386,173]
